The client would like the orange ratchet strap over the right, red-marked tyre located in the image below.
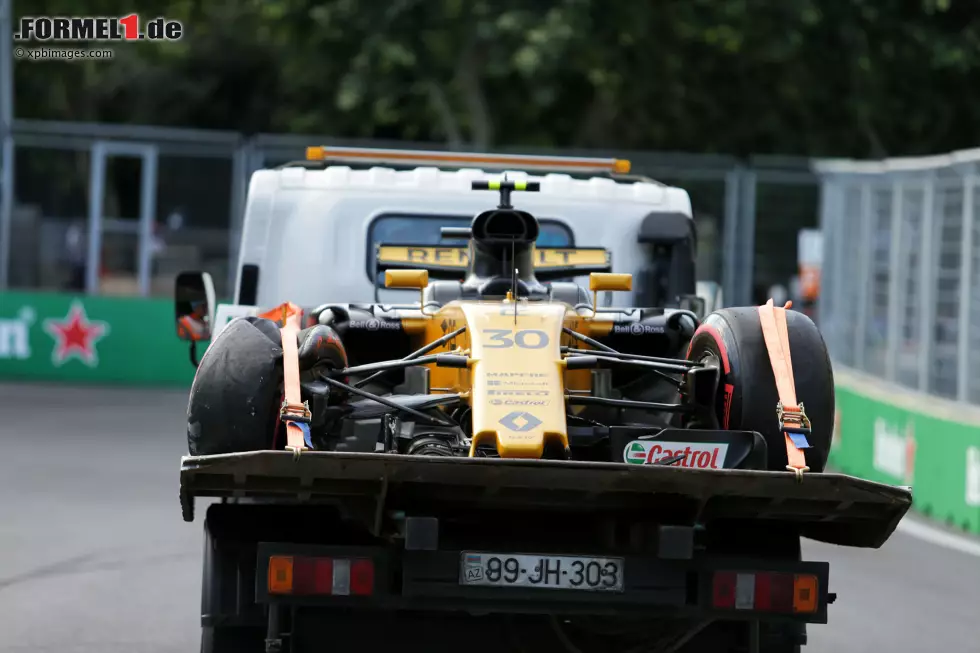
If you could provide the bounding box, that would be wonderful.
[759,299,810,480]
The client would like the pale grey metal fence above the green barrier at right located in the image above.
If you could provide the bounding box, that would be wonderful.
[814,149,980,404]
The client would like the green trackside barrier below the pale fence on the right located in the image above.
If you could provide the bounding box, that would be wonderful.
[830,367,980,533]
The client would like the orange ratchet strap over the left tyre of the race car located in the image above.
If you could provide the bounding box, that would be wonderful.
[260,302,313,456]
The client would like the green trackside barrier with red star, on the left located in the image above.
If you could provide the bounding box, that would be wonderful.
[0,292,208,387]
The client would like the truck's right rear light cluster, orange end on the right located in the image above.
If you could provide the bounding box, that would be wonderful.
[711,571,820,613]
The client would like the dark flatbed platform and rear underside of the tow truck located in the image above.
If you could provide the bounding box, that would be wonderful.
[181,451,909,653]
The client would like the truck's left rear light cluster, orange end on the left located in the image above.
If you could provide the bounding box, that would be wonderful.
[268,556,374,596]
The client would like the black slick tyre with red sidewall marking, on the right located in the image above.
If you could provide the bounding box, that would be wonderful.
[687,306,835,472]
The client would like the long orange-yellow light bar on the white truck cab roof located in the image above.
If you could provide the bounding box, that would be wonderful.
[306,145,631,175]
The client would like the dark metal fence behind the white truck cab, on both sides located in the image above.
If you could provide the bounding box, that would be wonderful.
[0,120,818,303]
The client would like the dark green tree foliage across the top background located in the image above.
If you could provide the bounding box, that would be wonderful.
[9,0,980,157]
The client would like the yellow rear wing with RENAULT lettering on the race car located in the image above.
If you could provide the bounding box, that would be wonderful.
[375,243,612,281]
